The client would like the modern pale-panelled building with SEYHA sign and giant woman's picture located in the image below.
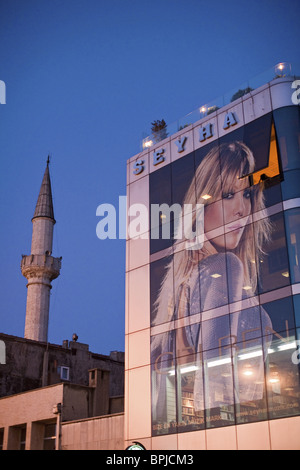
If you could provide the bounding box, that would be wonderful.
[125,71,300,450]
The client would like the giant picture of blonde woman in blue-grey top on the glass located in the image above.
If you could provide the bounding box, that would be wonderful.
[150,114,286,434]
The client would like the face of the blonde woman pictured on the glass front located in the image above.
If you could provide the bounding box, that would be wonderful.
[204,180,251,250]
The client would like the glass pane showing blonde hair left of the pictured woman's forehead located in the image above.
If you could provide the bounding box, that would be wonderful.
[195,140,222,204]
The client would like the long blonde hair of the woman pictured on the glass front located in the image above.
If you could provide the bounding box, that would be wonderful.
[153,142,270,324]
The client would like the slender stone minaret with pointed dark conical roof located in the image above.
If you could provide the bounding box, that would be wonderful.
[21,157,61,342]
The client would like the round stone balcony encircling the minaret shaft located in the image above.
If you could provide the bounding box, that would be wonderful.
[21,253,62,281]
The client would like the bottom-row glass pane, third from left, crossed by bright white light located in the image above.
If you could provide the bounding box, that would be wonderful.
[203,349,235,428]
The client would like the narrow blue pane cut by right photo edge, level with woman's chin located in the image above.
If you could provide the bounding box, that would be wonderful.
[284,208,300,284]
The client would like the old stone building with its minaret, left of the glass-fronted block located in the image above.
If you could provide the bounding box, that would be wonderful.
[0,159,124,450]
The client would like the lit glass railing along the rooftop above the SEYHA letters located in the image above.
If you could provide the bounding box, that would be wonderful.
[141,62,300,151]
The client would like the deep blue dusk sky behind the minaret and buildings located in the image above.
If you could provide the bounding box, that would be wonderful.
[0,0,300,354]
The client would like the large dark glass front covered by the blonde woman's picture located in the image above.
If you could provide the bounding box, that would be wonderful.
[150,110,300,435]
